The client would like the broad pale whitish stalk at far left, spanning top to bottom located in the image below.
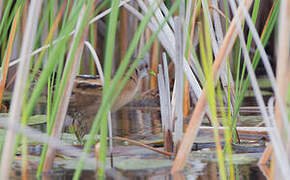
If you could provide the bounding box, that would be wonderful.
[0,0,42,180]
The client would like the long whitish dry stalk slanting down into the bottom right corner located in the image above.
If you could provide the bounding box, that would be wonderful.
[230,1,290,179]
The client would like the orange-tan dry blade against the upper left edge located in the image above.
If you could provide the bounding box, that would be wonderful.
[0,7,21,109]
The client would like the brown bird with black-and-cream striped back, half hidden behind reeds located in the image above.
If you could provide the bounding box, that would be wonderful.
[66,60,148,142]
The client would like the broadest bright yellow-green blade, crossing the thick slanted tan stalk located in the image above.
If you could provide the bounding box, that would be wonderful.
[200,12,227,180]
